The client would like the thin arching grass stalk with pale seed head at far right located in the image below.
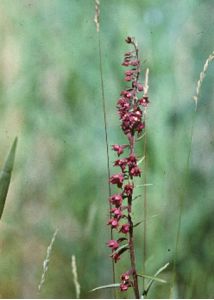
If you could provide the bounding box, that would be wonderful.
[169,51,214,298]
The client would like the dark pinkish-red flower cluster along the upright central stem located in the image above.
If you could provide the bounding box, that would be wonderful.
[107,37,149,291]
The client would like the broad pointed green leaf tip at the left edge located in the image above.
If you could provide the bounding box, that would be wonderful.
[0,137,17,219]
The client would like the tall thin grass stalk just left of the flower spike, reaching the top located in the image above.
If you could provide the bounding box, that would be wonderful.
[94,0,116,290]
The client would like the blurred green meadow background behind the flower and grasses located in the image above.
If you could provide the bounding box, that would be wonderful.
[0,0,214,298]
